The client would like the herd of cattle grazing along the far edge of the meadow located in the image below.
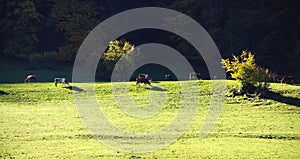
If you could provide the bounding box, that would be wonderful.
[24,72,295,87]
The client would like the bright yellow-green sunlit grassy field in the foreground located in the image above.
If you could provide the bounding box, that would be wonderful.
[0,81,300,158]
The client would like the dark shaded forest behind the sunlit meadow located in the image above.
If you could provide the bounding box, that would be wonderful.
[0,0,300,78]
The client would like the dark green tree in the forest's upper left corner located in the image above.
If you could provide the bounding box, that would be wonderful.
[0,0,41,58]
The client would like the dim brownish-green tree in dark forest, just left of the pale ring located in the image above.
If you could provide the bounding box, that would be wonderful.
[52,0,98,61]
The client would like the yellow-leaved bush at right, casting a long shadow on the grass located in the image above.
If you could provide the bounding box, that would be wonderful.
[221,51,270,94]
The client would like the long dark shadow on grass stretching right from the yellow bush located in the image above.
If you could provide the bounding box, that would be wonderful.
[262,91,300,107]
